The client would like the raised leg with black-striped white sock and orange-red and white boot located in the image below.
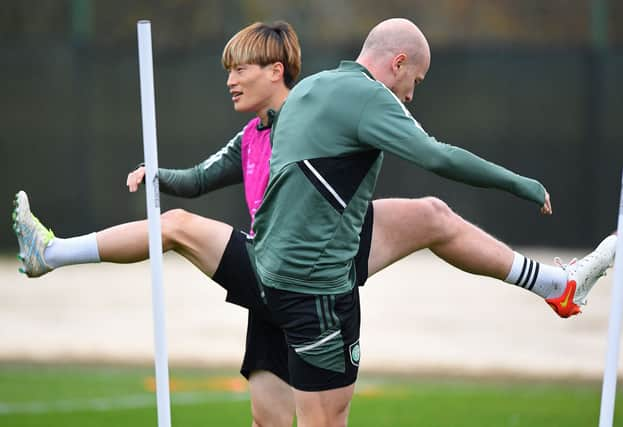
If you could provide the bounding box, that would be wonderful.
[369,197,616,317]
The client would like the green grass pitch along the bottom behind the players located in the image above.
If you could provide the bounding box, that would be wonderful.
[0,363,623,427]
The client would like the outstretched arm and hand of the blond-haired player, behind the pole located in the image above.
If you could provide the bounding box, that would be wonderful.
[127,131,242,198]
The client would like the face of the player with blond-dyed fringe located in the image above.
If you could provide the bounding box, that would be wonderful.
[227,64,273,113]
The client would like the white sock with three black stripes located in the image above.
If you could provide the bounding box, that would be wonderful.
[505,252,567,298]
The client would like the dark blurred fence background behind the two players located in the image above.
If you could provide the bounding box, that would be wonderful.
[0,0,623,250]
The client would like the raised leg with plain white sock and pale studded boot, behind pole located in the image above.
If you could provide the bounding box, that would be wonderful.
[13,191,232,277]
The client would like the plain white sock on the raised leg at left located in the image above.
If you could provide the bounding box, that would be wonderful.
[43,233,100,268]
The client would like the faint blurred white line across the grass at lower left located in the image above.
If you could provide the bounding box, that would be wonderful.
[0,392,249,415]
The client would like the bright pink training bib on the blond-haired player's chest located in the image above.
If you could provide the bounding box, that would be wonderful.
[240,117,272,236]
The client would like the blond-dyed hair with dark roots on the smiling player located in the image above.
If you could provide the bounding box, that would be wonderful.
[221,21,301,89]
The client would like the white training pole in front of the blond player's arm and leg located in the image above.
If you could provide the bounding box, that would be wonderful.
[136,21,171,427]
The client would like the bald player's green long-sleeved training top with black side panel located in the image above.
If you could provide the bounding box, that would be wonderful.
[253,61,545,295]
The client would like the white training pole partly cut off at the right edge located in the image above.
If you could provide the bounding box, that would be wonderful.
[599,174,623,427]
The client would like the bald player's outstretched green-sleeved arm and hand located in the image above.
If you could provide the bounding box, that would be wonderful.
[358,88,551,213]
